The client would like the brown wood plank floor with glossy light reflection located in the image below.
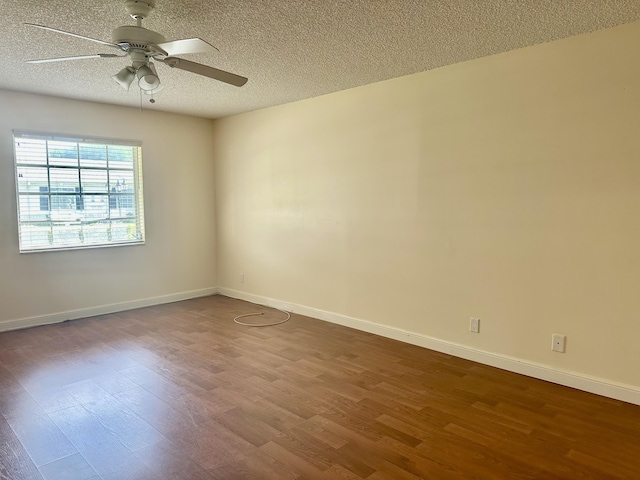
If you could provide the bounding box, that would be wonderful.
[0,296,640,480]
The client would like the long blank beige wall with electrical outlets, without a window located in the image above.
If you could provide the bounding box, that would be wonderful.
[215,23,640,388]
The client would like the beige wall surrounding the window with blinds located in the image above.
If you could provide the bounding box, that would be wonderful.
[0,90,217,330]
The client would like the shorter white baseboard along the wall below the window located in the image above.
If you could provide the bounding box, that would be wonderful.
[0,287,218,332]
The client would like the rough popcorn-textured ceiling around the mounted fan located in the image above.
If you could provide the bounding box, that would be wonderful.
[0,0,640,118]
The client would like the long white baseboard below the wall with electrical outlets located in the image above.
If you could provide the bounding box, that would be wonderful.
[218,287,640,405]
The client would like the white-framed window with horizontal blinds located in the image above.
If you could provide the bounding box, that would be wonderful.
[13,131,144,252]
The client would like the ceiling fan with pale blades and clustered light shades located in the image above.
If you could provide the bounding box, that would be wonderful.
[25,0,248,99]
